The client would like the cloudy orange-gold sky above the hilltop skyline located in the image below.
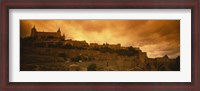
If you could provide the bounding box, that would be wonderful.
[20,20,180,58]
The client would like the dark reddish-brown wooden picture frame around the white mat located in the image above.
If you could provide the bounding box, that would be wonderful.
[0,0,200,91]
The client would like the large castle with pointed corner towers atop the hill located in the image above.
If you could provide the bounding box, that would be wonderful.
[31,26,65,41]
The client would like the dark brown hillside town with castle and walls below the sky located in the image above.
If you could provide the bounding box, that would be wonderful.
[20,26,180,71]
